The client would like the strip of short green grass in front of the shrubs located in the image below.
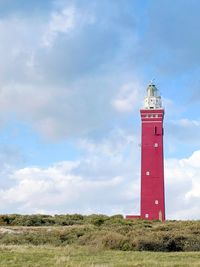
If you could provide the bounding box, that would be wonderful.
[0,246,200,267]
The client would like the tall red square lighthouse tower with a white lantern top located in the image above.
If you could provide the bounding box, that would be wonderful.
[126,83,165,221]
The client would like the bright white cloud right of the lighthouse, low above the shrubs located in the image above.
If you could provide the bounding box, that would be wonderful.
[165,150,200,219]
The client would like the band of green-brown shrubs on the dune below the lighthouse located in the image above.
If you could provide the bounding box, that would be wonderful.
[0,214,200,252]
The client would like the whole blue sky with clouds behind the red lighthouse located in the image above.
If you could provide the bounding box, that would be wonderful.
[0,0,200,220]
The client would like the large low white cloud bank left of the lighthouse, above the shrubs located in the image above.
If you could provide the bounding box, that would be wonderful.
[0,131,139,214]
